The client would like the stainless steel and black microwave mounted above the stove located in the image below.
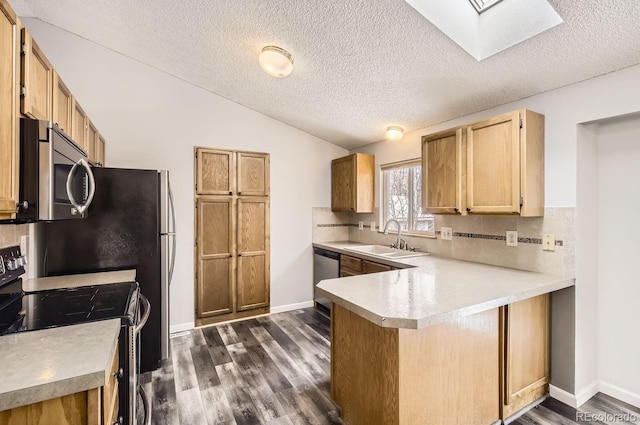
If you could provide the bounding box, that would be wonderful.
[15,118,95,223]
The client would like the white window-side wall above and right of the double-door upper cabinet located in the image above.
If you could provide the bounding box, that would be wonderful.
[354,65,640,400]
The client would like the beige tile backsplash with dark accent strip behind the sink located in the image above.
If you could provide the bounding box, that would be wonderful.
[313,207,575,276]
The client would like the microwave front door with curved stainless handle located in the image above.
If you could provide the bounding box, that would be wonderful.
[46,128,95,220]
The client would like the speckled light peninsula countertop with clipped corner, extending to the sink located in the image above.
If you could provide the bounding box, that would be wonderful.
[313,242,575,329]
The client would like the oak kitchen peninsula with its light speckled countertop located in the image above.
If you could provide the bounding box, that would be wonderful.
[314,242,575,425]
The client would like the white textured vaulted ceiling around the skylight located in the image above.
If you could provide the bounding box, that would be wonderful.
[9,0,640,148]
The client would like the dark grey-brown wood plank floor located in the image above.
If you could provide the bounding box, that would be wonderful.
[141,308,640,425]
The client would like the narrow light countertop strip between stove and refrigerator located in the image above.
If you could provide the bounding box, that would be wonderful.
[22,270,136,292]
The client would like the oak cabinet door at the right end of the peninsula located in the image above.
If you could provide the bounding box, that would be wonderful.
[500,294,549,419]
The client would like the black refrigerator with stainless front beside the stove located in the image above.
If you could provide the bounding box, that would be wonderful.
[37,168,176,373]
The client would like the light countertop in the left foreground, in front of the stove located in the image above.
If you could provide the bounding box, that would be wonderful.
[0,319,120,411]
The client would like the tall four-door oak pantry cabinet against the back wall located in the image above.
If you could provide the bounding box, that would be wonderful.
[195,148,270,324]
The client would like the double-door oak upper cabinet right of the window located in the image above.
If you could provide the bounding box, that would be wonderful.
[422,109,544,217]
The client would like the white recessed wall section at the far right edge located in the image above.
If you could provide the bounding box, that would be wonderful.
[594,116,640,407]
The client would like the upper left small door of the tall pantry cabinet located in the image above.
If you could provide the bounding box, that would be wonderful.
[196,148,236,195]
